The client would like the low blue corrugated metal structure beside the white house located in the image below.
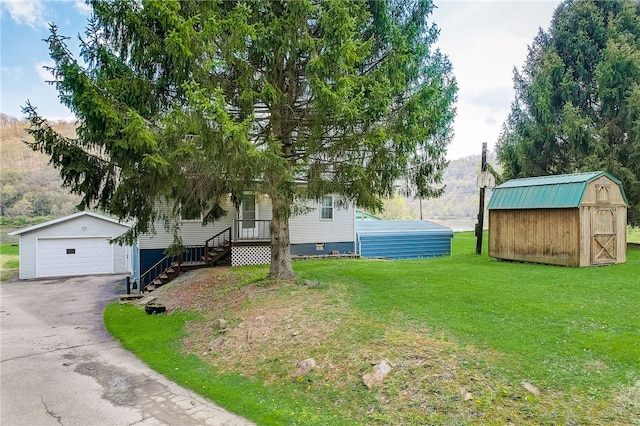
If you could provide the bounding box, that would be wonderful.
[356,220,453,259]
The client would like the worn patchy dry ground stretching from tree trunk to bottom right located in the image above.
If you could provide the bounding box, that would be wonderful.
[150,268,638,424]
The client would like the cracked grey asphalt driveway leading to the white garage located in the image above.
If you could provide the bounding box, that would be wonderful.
[0,276,250,426]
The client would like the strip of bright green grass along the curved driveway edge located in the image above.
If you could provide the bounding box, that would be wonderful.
[104,303,344,425]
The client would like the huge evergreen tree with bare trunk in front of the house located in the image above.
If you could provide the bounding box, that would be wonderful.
[25,0,456,278]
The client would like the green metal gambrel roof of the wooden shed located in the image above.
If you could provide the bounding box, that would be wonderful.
[488,172,628,210]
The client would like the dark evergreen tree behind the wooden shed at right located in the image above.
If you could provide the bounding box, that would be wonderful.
[497,0,640,225]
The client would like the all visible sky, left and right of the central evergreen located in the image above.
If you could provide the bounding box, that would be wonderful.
[0,0,560,160]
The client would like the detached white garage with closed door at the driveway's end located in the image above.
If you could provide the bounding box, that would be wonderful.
[9,212,131,279]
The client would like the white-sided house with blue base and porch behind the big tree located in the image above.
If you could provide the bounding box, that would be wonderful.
[133,192,356,287]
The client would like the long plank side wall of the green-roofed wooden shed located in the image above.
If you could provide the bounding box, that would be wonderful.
[489,209,581,266]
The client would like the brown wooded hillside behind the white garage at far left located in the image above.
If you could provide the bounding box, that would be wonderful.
[0,114,80,217]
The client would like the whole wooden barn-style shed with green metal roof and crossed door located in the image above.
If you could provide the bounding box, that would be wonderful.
[488,172,628,266]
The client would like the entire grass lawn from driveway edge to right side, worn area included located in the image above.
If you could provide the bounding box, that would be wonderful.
[105,233,640,425]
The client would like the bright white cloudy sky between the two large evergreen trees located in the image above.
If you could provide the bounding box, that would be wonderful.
[432,0,560,159]
